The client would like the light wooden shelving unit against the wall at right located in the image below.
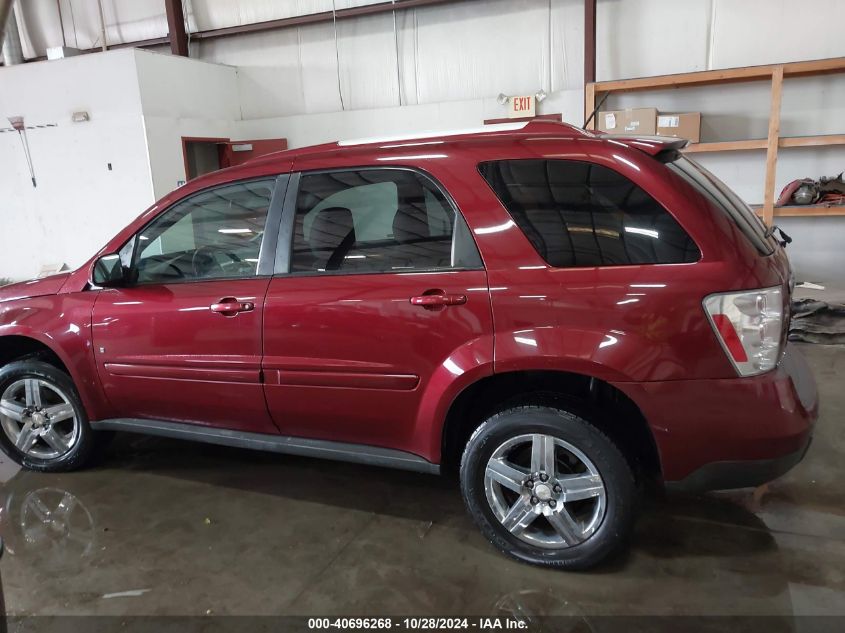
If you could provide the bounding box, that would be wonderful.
[584,57,845,225]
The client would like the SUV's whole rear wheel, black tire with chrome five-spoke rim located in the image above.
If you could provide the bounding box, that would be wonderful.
[460,403,638,571]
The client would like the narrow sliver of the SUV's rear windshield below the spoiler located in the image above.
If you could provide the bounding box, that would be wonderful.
[667,154,774,255]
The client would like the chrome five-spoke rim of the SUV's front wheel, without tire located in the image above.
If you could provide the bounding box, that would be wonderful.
[0,378,80,459]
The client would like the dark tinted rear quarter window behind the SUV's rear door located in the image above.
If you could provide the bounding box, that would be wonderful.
[479,159,701,268]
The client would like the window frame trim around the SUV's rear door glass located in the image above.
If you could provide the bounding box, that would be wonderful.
[274,165,486,277]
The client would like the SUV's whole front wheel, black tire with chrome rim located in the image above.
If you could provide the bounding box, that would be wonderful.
[0,359,98,472]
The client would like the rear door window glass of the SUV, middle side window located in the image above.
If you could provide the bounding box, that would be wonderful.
[290,169,481,274]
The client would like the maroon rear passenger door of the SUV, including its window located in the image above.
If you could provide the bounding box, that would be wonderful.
[263,168,493,452]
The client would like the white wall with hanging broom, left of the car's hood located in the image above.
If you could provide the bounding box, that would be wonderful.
[0,50,153,279]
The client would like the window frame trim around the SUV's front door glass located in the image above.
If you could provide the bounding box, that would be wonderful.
[118,173,290,288]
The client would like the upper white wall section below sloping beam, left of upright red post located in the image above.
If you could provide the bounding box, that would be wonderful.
[199,0,584,119]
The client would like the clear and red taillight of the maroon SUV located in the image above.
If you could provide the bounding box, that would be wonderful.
[704,286,783,376]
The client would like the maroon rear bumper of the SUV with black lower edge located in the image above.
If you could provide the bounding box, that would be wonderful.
[616,345,819,491]
